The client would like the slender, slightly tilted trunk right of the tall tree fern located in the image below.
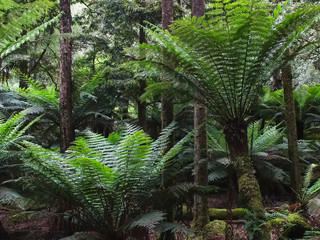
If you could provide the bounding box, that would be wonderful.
[282,65,301,197]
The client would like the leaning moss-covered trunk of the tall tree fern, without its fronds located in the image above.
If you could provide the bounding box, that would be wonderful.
[224,120,263,214]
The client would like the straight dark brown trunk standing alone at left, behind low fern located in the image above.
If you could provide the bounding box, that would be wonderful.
[59,0,75,152]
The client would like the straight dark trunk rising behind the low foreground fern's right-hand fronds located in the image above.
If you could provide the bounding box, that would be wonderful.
[161,0,173,133]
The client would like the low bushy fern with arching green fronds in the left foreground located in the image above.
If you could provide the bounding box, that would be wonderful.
[15,125,200,240]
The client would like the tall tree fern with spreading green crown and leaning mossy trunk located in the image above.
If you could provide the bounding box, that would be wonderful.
[132,0,320,213]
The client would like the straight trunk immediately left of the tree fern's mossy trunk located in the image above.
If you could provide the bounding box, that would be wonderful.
[192,0,209,229]
